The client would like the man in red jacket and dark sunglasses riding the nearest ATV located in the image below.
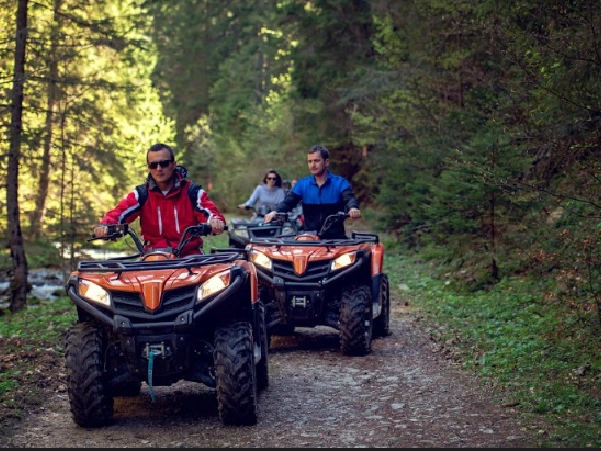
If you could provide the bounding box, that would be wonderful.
[94,143,225,257]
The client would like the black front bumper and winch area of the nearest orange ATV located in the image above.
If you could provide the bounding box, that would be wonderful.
[67,269,261,387]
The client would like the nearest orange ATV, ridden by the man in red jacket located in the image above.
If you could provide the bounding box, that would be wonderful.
[65,224,269,427]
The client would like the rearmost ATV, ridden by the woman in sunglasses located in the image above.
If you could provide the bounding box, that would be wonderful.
[228,205,297,249]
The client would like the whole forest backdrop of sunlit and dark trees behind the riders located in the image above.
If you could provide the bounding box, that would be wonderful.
[0,0,601,322]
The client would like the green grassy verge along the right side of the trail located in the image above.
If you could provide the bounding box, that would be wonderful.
[387,251,601,448]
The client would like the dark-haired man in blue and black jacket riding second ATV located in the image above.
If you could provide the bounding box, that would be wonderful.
[265,145,361,238]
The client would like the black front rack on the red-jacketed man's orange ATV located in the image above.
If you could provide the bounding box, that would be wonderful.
[77,250,240,272]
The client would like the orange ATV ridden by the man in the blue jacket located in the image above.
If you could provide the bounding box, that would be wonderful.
[246,212,390,355]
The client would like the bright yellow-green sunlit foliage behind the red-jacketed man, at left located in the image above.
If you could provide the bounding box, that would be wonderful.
[0,0,173,241]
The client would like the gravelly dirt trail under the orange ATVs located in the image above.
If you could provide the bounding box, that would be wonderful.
[2,301,537,448]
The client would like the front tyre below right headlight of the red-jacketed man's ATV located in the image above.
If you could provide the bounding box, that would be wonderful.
[213,322,257,426]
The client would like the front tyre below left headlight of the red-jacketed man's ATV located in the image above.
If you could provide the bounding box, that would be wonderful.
[65,322,114,427]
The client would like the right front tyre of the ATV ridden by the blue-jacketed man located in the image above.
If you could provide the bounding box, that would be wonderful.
[339,286,373,356]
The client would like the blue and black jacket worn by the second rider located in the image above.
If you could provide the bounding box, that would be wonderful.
[276,170,359,238]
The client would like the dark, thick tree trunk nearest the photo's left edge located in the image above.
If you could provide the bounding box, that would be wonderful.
[6,0,28,313]
